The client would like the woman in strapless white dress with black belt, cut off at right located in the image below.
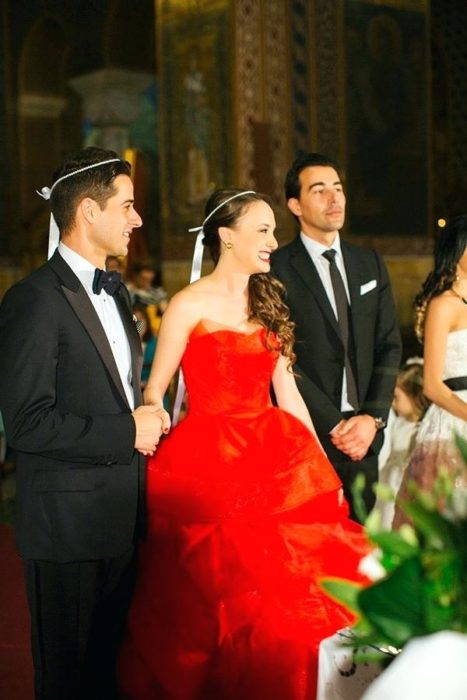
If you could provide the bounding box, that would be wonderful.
[393,215,467,527]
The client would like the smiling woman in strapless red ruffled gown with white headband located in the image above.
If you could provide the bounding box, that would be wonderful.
[119,190,368,700]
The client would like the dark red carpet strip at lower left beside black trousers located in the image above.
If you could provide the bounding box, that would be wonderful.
[0,523,33,700]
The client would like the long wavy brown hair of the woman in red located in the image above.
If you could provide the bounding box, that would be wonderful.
[203,189,295,365]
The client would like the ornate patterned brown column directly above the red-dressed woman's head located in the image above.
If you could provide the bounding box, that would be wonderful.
[234,0,292,220]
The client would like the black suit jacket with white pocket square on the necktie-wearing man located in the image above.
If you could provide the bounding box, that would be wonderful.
[272,236,401,454]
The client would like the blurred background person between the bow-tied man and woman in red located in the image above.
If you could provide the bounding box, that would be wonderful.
[127,260,167,333]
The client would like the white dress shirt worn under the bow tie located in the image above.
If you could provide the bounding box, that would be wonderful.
[58,242,135,409]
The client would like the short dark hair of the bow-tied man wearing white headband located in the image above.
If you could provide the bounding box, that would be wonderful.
[50,146,131,234]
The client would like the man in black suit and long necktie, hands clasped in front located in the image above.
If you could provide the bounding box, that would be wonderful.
[272,153,401,518]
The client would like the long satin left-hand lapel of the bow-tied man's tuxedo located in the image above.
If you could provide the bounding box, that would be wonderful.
[49,252,132,407]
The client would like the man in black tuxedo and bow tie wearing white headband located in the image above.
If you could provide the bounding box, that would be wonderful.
[0,148,168,700]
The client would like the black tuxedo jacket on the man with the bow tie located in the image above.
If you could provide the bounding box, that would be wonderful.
[0,252,144,562]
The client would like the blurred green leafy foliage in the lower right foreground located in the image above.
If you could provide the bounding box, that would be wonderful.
[322,437,467,650]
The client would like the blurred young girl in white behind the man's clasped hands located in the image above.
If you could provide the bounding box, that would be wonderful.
[375,357,429,530]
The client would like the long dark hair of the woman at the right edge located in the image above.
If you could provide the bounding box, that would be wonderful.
[415,214,467,343]
